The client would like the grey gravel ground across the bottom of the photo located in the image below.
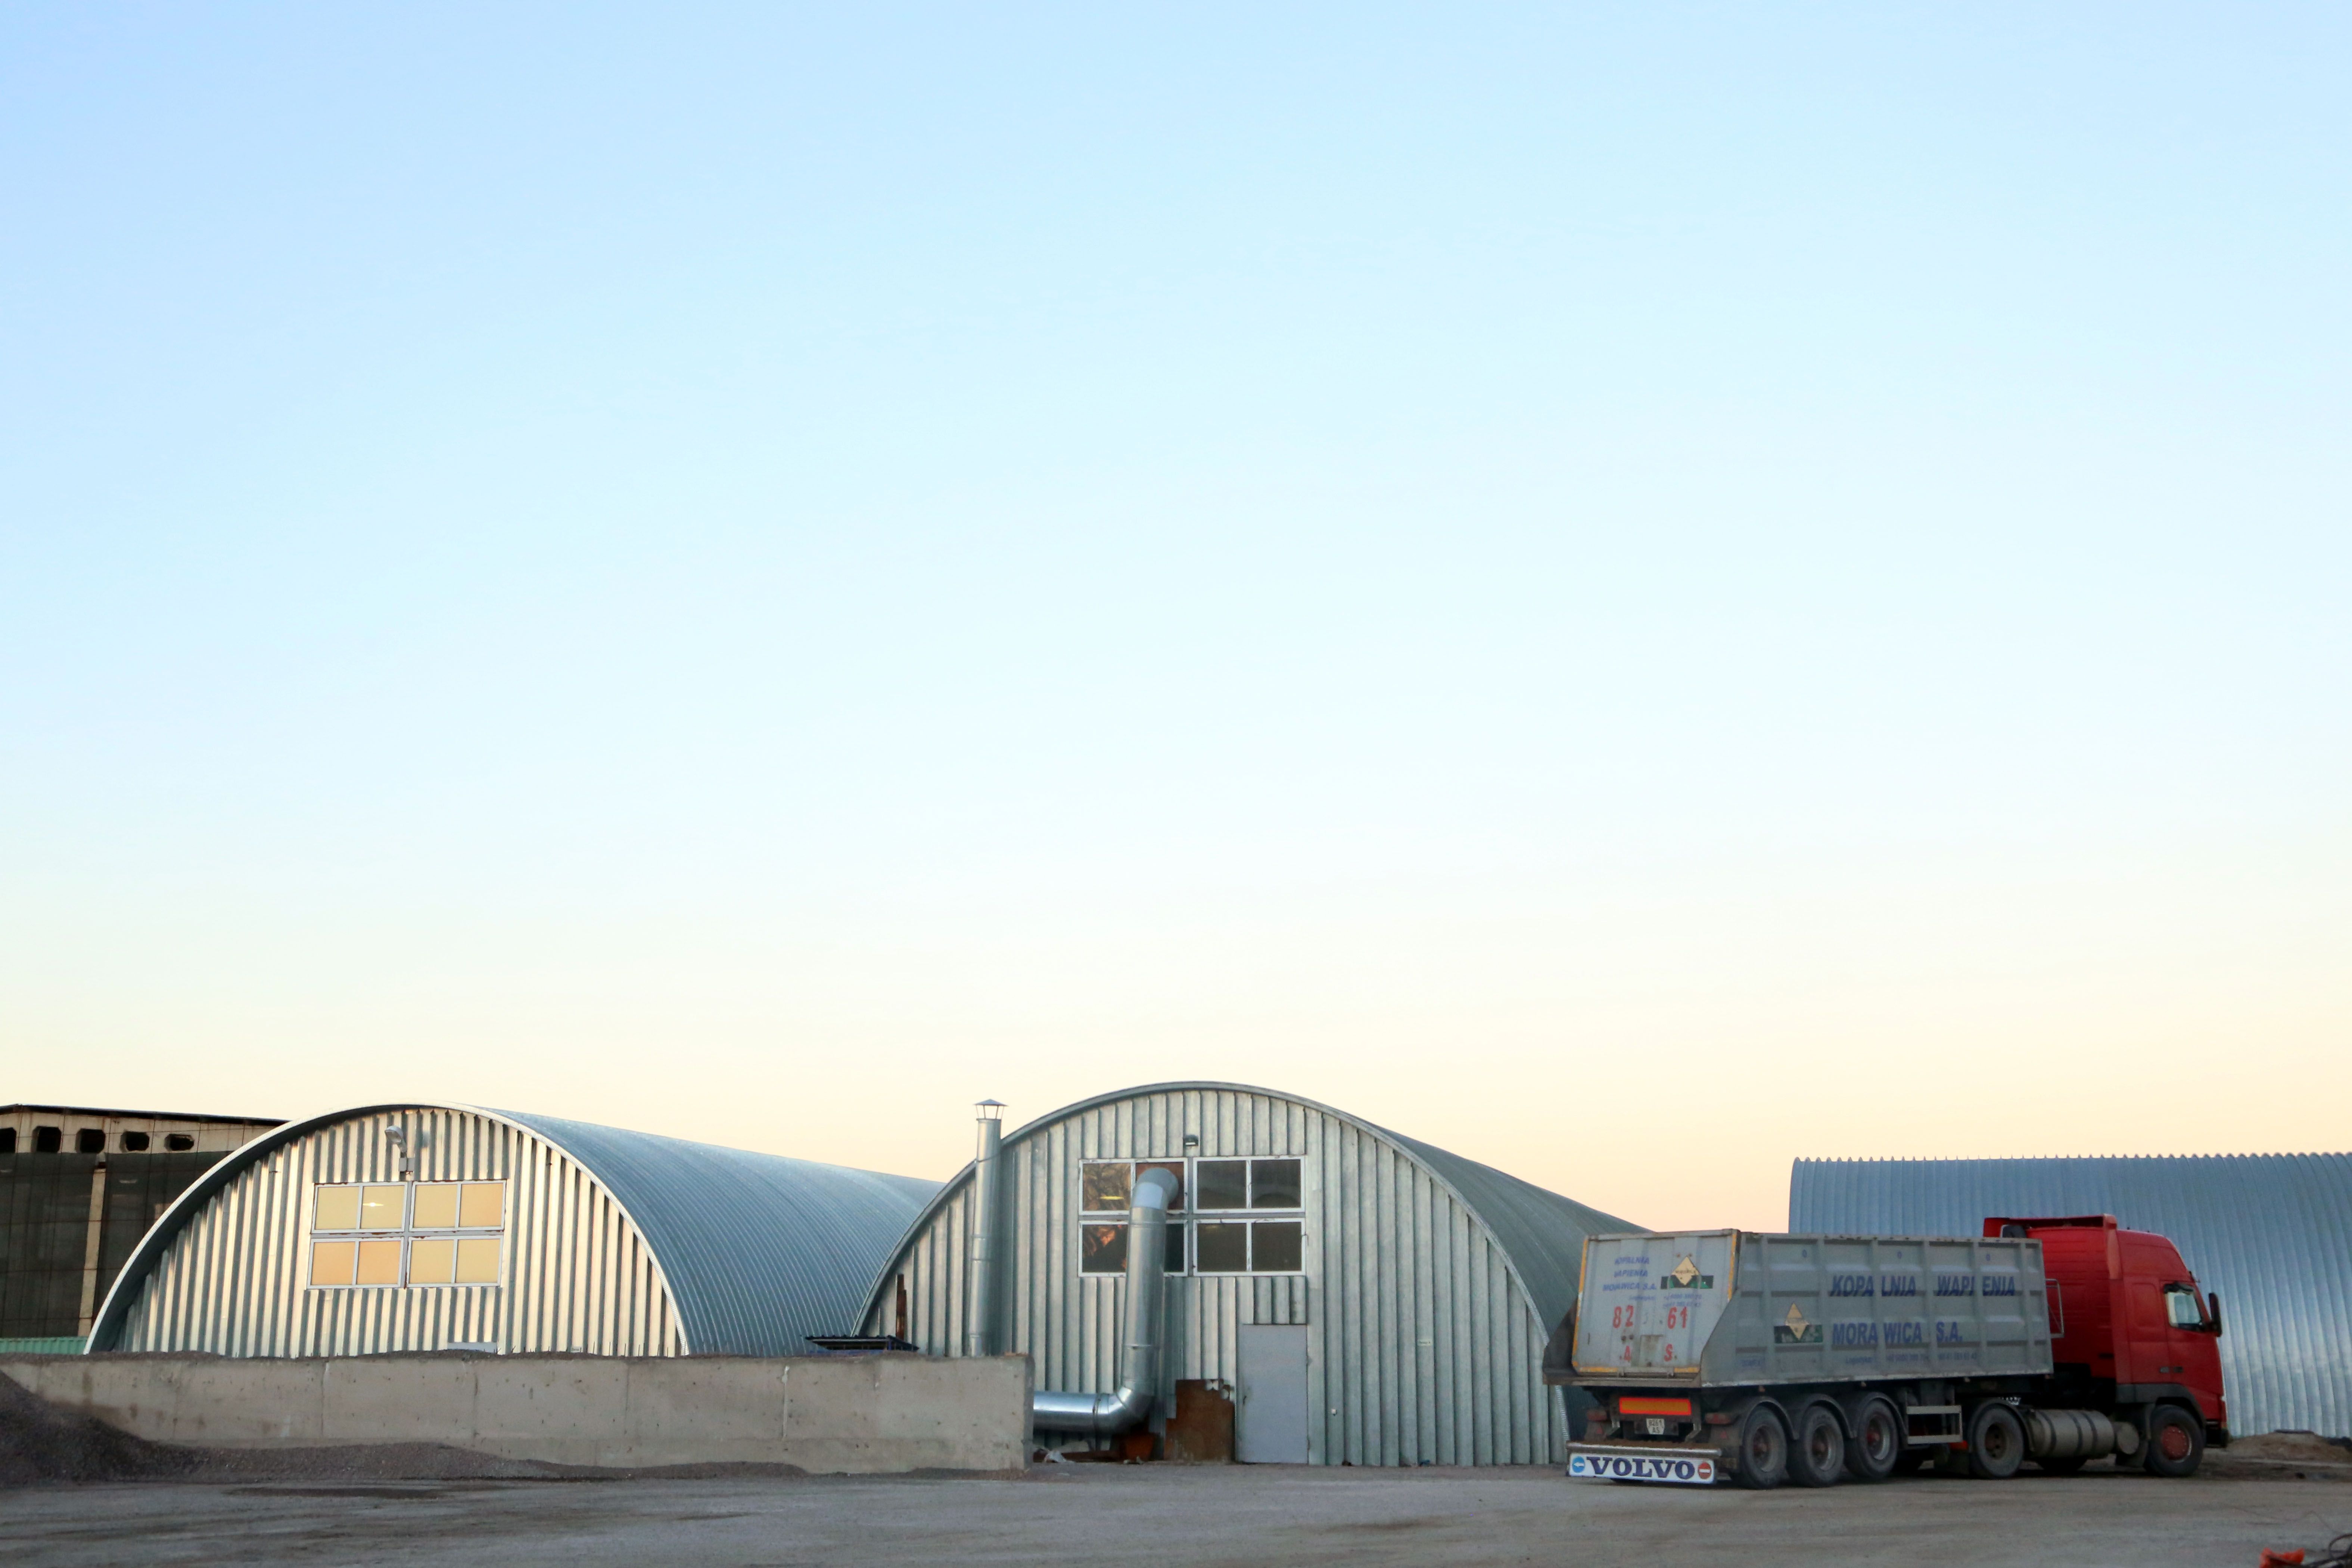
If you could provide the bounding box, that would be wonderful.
[0,1465,2352,1568]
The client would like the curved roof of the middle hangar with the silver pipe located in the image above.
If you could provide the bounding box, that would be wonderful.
[865,1079,1644,1328]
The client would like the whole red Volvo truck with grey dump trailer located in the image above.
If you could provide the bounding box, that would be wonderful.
[1543,1215,2230,1488]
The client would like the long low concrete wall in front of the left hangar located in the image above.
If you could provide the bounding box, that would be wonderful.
[0,1354,1030,1474]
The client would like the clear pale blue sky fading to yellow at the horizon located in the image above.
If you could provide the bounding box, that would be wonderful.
[0,5,2352,1225]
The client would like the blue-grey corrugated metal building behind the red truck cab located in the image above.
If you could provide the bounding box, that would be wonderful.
[1788,1154,2352,1436]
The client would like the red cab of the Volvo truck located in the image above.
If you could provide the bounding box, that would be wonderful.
[1985,1213,2230,1446]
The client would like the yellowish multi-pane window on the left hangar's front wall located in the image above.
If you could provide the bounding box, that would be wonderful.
[311,1182,506,1286]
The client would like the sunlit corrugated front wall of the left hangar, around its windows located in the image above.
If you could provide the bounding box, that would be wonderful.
[111,1110,687,1356]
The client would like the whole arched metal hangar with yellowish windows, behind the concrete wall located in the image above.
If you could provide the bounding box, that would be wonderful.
[89,1105,939,1356]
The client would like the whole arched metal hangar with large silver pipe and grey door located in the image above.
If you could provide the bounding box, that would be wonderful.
[865,1084,1639,1465]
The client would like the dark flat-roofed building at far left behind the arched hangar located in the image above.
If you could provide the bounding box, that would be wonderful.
[0,1105,277,1352]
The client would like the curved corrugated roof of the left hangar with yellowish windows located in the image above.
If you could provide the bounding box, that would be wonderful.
[89,1100,939,1356]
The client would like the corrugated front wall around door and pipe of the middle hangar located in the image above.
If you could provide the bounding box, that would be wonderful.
[865,1086,1632,1465]
